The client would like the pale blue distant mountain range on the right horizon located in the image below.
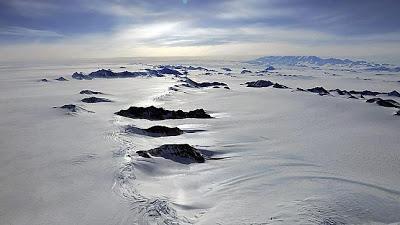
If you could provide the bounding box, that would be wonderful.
[248,56,400,72]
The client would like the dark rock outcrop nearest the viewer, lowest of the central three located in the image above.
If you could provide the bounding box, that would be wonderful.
[136,144,206,164]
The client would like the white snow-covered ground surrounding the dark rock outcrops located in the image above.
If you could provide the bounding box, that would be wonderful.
[0,59,400,225]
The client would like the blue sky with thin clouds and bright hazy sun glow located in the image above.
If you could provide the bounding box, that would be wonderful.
[0,0,400,64]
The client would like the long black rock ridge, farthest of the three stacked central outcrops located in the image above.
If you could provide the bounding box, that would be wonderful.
[115,106,212,120]
